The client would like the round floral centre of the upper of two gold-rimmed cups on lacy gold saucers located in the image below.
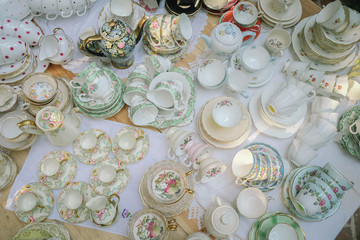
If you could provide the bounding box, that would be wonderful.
[152,170,184,201]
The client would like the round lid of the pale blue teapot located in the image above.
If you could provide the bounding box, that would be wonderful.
[214,22,242,45]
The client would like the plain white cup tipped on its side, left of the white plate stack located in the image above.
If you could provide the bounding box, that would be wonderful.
[226,68,249,98]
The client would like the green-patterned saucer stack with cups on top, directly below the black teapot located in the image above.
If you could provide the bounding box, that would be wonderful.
[70,63,125,118]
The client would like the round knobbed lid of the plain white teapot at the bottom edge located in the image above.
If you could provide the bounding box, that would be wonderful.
[211,205,239,235]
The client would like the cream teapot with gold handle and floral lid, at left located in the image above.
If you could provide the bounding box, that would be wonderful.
[17,106,81,147]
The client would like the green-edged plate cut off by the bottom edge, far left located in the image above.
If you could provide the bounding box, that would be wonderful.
[12,221,70,240]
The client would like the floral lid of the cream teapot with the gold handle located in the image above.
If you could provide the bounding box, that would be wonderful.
[36,106,64,131]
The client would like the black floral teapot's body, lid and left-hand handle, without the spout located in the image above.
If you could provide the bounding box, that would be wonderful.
[84,20,136,69]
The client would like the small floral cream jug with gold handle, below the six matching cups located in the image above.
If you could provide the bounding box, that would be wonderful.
[85,194,120,226]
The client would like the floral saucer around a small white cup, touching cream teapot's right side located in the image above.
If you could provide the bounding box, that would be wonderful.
[73,128,111,164]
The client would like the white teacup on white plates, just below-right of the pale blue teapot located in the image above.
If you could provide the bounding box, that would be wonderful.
[241,46,275,72]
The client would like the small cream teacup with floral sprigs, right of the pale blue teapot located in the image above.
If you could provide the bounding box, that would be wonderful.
[265,28,291,56]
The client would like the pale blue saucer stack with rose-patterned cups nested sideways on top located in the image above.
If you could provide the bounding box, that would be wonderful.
[283,163,353,222]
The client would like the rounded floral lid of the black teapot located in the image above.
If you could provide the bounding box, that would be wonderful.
[100,20,135,41]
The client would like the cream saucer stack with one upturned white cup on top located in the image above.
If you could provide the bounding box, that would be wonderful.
[196,96,252,149]
